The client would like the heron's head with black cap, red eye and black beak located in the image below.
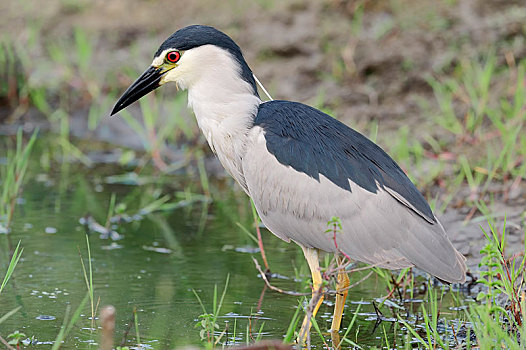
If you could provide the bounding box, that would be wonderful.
[111,25,257,115]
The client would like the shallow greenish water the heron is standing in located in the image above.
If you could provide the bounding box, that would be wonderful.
[0,139,470,349]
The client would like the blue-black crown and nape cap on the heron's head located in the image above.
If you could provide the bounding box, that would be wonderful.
[155,25,258,95]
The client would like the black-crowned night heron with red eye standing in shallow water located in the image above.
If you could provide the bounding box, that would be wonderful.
[111,25,466,341]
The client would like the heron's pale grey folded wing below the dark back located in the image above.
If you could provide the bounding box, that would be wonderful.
[242,126,466,282]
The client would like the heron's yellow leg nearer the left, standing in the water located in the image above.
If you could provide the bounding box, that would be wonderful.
[298,246,323,345]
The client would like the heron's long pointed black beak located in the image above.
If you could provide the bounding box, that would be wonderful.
[110,66,166,116]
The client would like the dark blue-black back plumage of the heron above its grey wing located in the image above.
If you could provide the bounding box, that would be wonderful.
[254,101,436,223]
